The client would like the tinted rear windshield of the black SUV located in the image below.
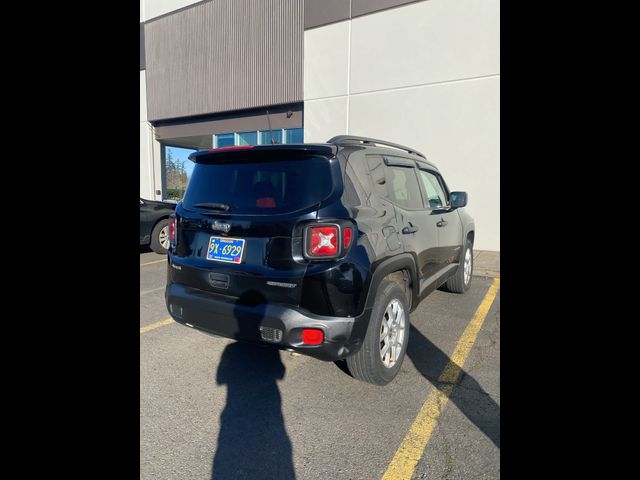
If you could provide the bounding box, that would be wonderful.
[182,157,332,215]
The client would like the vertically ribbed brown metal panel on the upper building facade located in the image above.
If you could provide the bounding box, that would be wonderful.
[145,0,304,121]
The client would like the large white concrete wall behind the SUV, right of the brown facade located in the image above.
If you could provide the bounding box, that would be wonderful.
[304,0,500,251]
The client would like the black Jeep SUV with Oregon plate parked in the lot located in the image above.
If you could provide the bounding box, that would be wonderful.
[165,135,475,385]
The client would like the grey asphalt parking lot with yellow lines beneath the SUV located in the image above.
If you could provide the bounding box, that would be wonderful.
[140,251,500,480]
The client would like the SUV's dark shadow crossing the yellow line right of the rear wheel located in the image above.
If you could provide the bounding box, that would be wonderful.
[407,325,500,448]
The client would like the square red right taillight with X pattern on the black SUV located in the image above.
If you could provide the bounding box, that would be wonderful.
[304,223,353,260]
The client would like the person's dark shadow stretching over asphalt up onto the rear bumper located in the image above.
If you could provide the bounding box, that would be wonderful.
[211,292,296,480]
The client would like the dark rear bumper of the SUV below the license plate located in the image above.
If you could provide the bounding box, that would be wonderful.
[165,283,371,361]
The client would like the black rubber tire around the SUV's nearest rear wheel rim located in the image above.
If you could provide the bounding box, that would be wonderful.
[346,280,410,385]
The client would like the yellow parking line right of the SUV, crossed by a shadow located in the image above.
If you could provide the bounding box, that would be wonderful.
[382,278,500,480]
